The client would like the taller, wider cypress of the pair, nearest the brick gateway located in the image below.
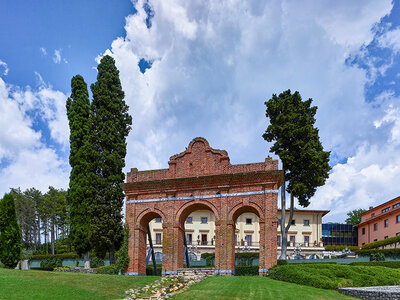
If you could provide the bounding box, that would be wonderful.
[90,55,132,263]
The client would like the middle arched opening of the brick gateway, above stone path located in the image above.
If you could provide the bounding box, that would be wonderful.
[178,202,216,267]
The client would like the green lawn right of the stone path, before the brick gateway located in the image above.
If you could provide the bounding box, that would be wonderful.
[172,276,354,300]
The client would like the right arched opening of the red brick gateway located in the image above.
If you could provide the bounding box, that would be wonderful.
[232,206,261,275]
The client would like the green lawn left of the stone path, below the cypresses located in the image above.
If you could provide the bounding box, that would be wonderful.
[0,268,160,300]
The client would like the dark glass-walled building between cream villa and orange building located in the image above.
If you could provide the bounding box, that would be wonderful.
[322,224,358,246]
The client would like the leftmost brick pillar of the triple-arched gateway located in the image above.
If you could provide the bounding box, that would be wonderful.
[126,227,146,275]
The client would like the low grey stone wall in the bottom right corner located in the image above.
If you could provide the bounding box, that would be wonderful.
[339,285,400,300]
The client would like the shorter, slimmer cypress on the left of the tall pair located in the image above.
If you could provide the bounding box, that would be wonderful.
[67,75,94,268]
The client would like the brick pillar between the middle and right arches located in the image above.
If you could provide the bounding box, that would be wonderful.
[215,220,235,275]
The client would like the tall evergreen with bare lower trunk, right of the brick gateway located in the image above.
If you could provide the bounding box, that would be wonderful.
[263,90,331,259]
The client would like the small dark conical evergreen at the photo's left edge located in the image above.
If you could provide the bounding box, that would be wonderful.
[0,193,22,268]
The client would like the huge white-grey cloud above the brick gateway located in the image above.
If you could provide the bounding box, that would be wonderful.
[96,0,397,221]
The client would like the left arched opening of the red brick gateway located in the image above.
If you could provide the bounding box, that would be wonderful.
[139,211,163,275]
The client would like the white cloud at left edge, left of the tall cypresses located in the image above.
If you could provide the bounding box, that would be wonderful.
[0,72,69,194]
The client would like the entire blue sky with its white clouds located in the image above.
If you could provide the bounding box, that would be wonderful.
[0,0,400,221]
